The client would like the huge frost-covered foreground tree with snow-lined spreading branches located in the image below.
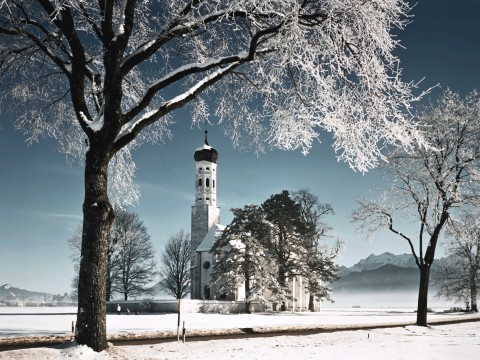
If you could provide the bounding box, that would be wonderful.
[0,0,423,351]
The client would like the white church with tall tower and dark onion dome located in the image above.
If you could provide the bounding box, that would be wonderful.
[190,131,308,310]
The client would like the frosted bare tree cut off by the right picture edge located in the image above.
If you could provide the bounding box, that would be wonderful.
[437,209,480,312]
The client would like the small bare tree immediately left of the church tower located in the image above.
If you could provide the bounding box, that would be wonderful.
[160,230,191,299]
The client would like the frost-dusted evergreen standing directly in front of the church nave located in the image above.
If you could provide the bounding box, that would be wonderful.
[211,205,276,313]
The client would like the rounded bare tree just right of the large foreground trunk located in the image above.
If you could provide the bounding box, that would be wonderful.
[111,210,158,300]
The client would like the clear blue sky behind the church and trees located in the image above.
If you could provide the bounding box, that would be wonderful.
[0,0,480,293]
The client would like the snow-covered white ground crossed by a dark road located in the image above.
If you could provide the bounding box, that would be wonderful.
[0,308,480,360]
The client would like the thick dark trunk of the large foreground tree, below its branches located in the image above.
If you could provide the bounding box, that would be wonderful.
[75,150,114,351]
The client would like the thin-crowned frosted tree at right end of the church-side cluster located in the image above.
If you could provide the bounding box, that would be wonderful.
[292,189,343,311]
